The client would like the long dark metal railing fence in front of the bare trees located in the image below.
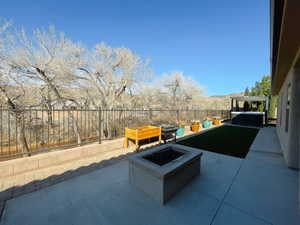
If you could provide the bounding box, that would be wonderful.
[0,106,229,160]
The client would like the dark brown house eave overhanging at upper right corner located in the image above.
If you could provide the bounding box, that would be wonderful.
[271,0,300,95]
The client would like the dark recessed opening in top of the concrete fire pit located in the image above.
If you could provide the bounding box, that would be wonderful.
[143,148,184,166]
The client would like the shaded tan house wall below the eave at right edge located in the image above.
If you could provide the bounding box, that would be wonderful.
[277,65,300,169]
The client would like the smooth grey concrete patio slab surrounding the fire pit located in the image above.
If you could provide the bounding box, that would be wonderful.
[0,128,300,225]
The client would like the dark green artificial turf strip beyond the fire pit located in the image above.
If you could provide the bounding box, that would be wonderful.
[177,126,259,158]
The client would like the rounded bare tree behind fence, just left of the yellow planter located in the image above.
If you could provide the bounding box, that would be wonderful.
[77,43,150,138]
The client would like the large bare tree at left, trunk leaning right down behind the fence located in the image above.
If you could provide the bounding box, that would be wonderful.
[2,27,82,144]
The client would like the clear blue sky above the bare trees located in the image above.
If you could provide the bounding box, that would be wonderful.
[0,0,269,95]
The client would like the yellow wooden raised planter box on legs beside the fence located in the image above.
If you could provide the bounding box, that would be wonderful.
[124,126,161,148]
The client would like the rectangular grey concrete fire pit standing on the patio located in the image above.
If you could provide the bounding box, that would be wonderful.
[128,144,202,204]
